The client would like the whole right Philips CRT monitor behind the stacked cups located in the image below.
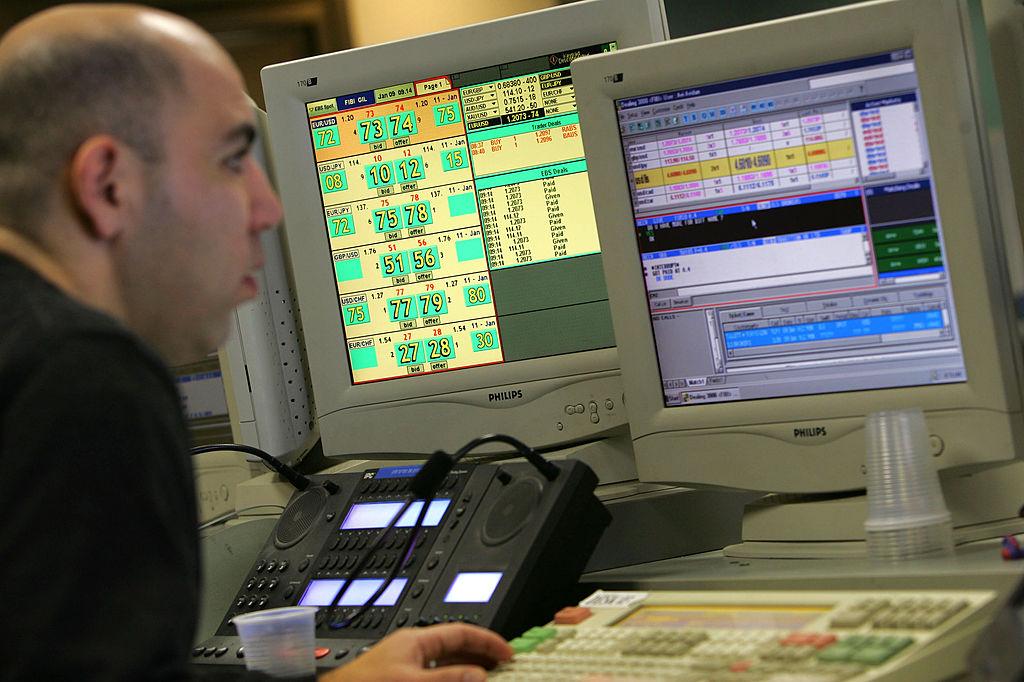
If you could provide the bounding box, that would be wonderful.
[572,0,1024,503]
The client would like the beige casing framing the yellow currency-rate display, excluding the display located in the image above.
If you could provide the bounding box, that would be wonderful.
[262,0,668,452]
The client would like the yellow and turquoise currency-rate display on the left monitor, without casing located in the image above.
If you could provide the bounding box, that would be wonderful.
[306,42,615,384]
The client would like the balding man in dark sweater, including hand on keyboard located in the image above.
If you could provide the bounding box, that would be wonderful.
[0,5,511,681]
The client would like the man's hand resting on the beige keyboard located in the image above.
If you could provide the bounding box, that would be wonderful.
[319,624,512,682]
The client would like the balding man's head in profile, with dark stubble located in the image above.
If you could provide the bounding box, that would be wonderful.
[0,5,281,363]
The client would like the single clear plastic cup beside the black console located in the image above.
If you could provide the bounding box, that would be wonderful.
[231,606,316,678]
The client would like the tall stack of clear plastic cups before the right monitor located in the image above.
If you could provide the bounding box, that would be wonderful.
[864,410,953,561]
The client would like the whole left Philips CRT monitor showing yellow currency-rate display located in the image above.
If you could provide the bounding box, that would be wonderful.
[263,0,667,455]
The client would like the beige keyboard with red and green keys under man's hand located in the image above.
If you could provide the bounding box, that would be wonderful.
[490,591,996,682]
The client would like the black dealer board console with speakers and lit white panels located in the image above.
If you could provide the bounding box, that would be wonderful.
[193,460,610,668]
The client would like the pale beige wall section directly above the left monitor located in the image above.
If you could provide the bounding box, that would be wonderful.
[345,0,559,46]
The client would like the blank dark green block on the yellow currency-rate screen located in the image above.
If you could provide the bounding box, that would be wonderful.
[490,254,615,363]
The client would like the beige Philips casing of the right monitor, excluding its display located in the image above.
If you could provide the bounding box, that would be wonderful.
[572,0,1024,492]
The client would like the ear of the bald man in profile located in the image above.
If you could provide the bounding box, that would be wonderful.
[69,135,143,241]
